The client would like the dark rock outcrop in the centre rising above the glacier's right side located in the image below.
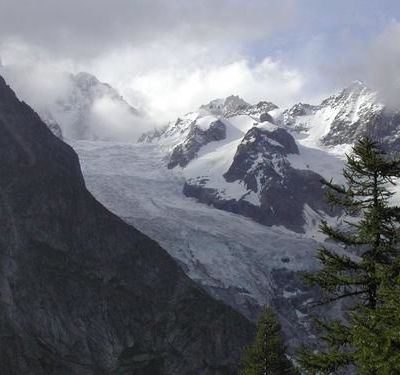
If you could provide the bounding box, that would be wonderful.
[184,124,330,232]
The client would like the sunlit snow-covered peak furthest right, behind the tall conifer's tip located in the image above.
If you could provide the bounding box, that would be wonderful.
[277,81,400,152]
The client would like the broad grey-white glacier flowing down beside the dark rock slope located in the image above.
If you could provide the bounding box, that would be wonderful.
[70,141,332,349]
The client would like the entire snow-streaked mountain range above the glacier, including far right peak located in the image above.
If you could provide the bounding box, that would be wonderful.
[141,81,400,233]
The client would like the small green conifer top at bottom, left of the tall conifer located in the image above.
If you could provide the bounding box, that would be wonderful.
[240,307,297,375]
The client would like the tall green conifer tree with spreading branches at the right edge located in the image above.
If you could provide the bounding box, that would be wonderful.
[299,138,400,374]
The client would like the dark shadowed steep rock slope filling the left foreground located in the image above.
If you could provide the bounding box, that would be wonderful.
[0,78,254,374]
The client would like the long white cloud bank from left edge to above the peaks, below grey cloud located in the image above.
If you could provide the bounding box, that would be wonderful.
[2,31,304,128]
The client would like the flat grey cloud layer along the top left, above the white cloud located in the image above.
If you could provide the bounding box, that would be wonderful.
[0,0,295,59]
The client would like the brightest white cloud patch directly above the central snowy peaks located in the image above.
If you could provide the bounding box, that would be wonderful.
[120,58,304,119]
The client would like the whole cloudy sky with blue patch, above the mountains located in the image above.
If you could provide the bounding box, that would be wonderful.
[0,0,400,118]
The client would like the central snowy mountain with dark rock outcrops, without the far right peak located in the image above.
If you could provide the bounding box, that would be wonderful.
[141,96,340,232]
